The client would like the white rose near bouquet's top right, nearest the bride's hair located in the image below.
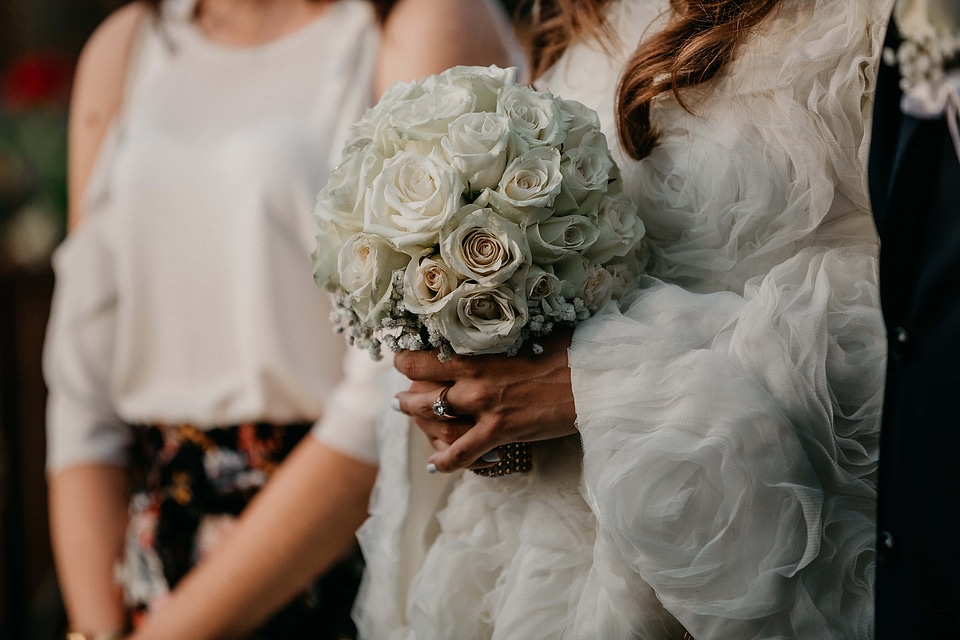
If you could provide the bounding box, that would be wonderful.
[497,85,569,154]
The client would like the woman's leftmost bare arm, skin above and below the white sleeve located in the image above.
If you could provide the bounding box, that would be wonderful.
[49,3,145,633]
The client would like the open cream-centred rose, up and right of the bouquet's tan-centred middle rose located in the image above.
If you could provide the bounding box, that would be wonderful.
[497,147,563,210]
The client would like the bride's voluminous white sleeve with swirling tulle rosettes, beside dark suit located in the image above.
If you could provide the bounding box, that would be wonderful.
[570,1,889,640]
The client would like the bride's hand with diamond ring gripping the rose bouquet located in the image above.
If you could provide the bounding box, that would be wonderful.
[394,332,577,472]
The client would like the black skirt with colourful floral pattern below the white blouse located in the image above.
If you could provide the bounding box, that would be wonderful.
[117,423,363,640]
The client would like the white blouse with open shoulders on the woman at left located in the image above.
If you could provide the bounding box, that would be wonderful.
[44,0,379,469]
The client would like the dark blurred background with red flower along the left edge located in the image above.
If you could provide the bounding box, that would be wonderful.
[0,0,517,640]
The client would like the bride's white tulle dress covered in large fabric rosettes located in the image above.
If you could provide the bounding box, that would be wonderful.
[355,0,891,640]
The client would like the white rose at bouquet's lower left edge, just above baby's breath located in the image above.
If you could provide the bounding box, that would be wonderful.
[337,233,410,327]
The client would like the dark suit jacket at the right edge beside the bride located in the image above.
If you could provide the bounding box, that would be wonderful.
[870,17,960,640]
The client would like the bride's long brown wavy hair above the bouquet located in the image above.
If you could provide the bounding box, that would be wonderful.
[520,0,781,160]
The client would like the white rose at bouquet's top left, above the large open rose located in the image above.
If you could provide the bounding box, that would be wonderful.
[380,85,476,155]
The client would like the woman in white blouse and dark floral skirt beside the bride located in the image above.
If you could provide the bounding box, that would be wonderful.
[45,0,508,637]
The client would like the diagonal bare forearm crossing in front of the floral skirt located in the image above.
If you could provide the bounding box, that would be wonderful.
[134,438,376,640]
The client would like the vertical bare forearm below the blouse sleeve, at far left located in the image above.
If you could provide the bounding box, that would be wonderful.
[49,464,128,633]
